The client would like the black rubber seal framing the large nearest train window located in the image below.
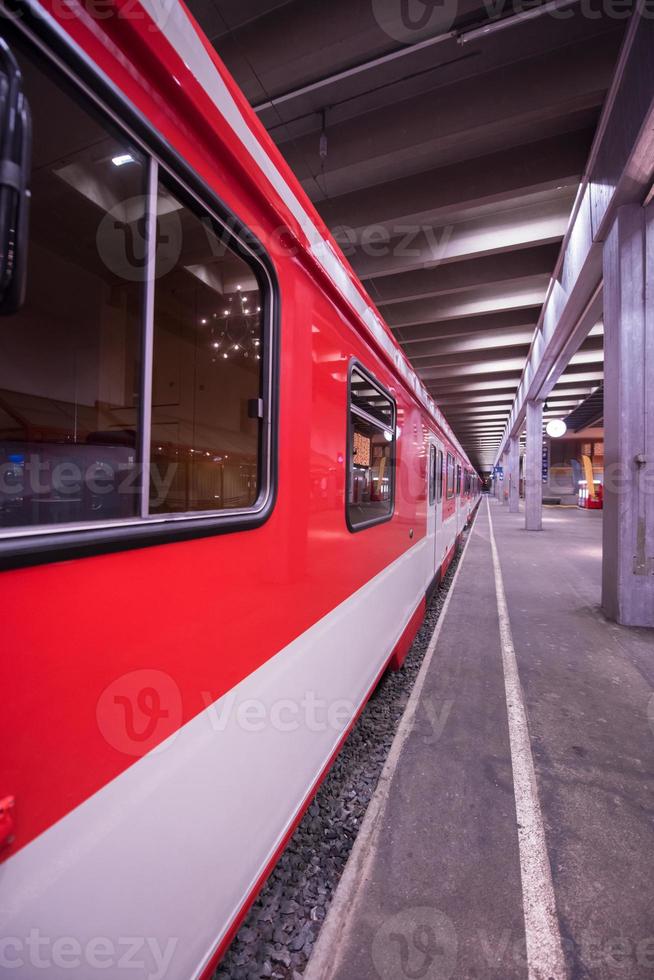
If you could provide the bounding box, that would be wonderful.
[0,0,281,571]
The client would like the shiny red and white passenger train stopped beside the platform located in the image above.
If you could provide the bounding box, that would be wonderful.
[0,0,479,980]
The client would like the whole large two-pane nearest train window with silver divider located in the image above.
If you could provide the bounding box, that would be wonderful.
[0,28,274,560]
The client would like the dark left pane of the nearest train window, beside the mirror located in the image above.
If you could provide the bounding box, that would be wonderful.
[0,42,147,529]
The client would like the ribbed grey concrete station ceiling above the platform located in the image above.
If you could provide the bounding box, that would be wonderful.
[190,0,625,470]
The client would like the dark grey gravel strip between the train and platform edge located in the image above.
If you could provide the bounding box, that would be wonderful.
[214,536,460,980]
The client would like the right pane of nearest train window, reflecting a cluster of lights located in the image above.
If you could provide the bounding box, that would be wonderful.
[150,184,262,514]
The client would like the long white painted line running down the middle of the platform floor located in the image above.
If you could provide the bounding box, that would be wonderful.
[486,499,567,980]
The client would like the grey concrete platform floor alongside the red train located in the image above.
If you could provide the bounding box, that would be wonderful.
[305,499,654,980]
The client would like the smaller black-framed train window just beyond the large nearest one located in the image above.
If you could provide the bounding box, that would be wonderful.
[346,364,395,531]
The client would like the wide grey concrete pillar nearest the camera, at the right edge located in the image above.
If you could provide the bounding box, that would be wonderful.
[602,204,654,626]
